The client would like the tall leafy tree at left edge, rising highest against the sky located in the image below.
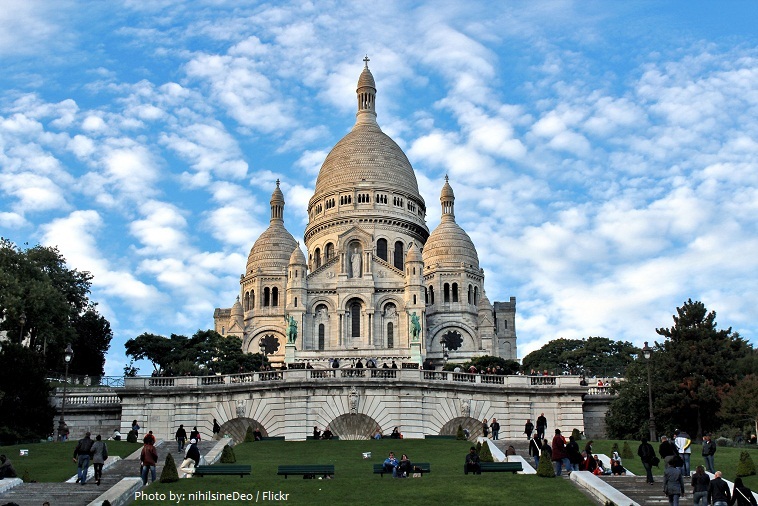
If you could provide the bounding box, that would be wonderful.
[0,238,113,376]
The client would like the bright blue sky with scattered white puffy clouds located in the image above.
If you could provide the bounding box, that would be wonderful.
[0,0,758,374]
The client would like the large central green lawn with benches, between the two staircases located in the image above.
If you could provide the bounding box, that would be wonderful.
[142,439,593,506]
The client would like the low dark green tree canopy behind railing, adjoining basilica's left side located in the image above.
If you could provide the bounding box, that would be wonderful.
[125,330,266,375]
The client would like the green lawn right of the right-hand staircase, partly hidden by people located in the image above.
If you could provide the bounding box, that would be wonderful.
[592,440,758,490]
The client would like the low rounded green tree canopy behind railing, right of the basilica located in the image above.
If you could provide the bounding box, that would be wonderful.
[522,337,640,377]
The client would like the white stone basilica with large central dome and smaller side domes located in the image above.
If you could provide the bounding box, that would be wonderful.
[214,60,516,368]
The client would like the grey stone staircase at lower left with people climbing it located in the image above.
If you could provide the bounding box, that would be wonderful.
[0,441,216,506]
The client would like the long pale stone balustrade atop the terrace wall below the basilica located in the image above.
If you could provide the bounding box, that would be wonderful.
[125,368,588,395]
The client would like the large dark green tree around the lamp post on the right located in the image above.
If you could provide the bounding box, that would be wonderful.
[606,299,756,437]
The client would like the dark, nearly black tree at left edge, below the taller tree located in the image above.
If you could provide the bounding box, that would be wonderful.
[0,343,55,443]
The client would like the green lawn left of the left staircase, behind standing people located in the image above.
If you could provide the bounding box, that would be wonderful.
[0,441,142,482]
